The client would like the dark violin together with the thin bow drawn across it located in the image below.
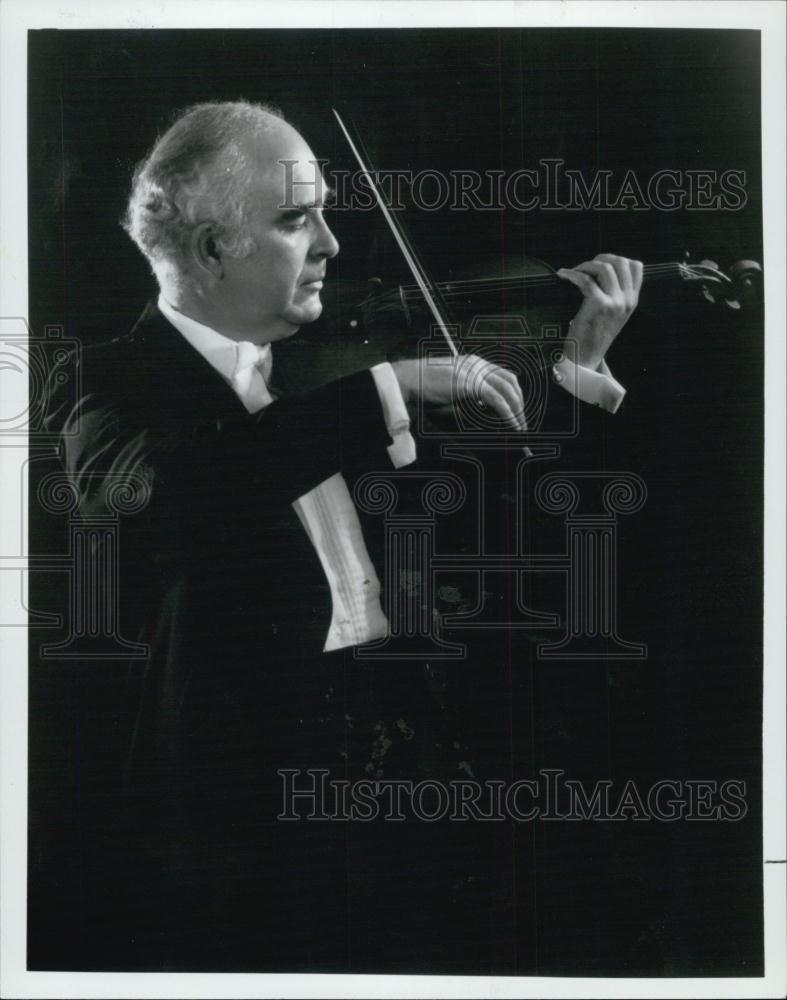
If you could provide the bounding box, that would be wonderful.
[277,111,762,392]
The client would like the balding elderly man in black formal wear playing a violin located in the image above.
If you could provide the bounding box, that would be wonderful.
[44,103,641,971]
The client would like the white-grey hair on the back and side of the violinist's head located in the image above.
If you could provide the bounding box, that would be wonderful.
[122,101,284,287]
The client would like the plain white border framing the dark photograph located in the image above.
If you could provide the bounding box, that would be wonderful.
[0,0,787,998]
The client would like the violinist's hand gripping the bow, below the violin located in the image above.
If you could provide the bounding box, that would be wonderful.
[391,354,527,431]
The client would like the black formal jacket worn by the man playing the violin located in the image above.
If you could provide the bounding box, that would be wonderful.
[43,296,620,971]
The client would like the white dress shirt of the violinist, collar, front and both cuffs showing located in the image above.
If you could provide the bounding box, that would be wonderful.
[158,295,625,652]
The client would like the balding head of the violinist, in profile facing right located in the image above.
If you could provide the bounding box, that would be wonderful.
[125,103,339,343]
